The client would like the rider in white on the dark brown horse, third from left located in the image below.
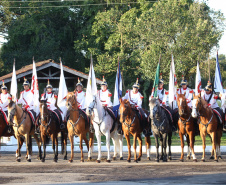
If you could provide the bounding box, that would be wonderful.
[41,80,64,129]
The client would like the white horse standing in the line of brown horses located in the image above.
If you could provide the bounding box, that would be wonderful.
[86,96,123,163]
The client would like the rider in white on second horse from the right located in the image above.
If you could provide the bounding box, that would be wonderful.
[177,75,193,109]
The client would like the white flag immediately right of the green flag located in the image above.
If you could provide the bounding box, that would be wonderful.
[169,55,177,109]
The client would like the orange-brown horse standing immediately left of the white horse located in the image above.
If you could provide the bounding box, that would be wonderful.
[66,92,94,163]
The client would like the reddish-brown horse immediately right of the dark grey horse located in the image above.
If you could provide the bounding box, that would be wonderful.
[177,92,197,162]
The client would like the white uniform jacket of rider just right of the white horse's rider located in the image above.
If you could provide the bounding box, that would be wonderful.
[122,90,144,108]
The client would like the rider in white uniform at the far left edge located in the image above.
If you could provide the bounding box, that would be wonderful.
[0,81,10,124]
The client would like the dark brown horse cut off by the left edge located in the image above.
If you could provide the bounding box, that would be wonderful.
[0,112,24,156]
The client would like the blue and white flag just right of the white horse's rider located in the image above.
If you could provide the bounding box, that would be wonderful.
[113,58,122,106]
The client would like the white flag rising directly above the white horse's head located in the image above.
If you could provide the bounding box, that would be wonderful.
[86,55,97,107]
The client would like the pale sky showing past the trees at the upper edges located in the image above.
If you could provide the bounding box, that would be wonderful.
[0,0,226,56]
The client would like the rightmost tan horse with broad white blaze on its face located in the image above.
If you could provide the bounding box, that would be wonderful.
[192,93,223,162]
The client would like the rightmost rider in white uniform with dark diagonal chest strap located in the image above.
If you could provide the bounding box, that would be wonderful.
[201,81,226,129]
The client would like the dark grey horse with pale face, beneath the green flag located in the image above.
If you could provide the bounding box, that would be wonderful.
[149,97,172,162]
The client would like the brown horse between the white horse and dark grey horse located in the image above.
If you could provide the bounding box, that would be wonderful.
[119,99,151,162]
